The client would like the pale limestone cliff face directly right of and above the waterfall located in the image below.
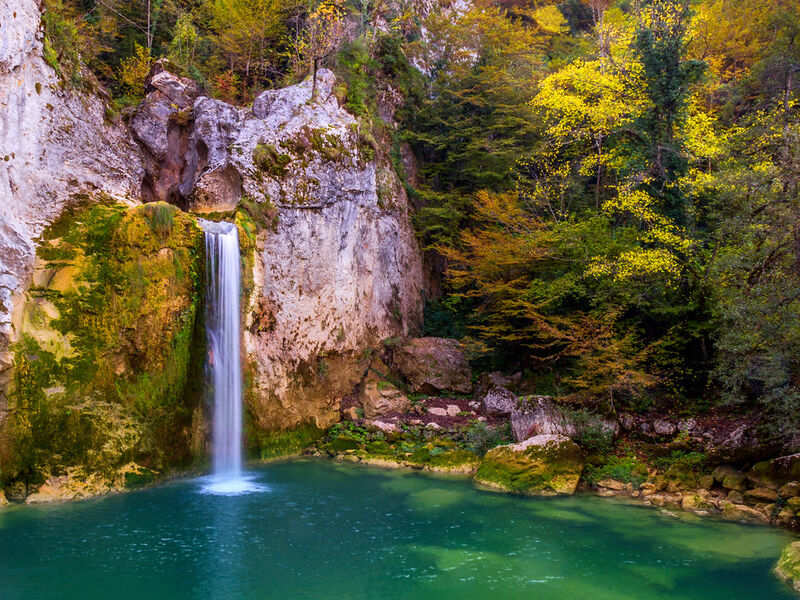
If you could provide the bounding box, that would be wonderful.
[133,70,423,429]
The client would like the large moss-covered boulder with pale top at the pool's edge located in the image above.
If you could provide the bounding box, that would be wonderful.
[475,435,585,496]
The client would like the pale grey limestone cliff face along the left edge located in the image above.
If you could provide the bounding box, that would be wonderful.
[0,0,143,421]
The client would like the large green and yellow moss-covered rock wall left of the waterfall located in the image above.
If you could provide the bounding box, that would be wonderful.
[0,199,204,500]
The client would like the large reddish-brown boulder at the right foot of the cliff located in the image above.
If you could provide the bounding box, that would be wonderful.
[391,337,472,394]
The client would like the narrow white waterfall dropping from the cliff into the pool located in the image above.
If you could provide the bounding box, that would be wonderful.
[200,219,264,494]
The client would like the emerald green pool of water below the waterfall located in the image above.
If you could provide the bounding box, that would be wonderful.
[0,460,793,600]
